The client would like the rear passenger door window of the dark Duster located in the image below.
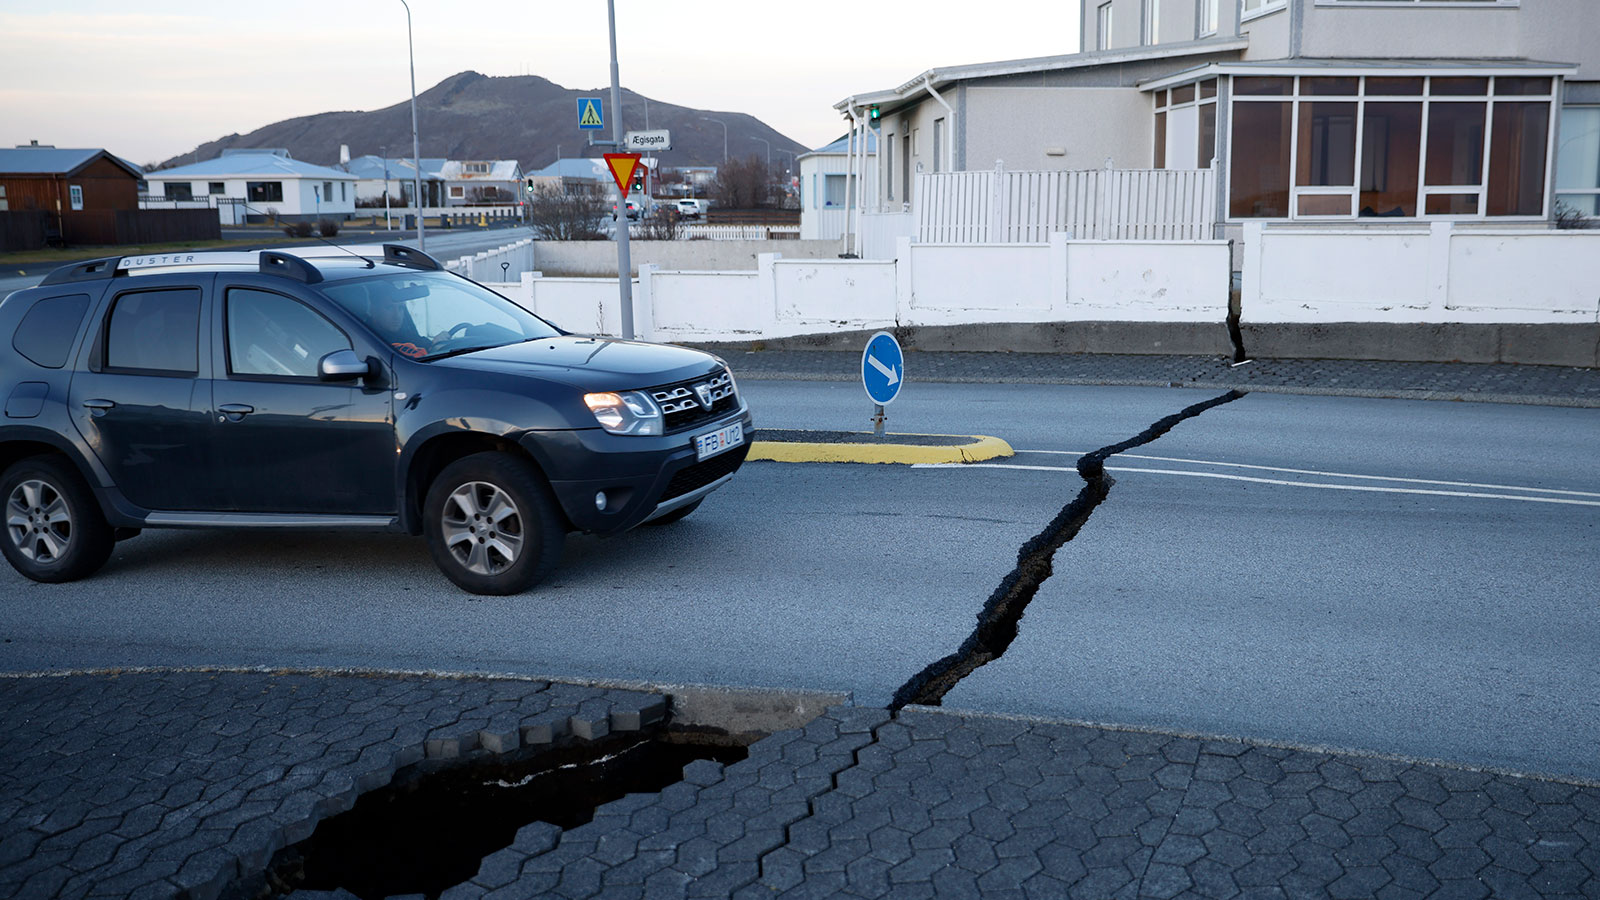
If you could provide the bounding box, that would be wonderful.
[106,288,200,375]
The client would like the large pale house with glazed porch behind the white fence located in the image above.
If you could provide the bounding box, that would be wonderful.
[835,0,1600,235]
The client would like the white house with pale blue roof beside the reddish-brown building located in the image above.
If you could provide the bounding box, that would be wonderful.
[144,151,355,221]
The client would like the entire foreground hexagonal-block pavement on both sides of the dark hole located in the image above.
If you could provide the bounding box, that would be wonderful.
[0,671,1600,900]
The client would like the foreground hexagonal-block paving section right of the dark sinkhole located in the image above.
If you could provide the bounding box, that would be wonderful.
[428,708,1600,900]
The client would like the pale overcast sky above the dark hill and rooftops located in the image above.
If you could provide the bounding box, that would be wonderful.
[0,0,1078,165]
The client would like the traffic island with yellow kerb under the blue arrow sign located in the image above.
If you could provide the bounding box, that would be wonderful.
[749,428,1014,464]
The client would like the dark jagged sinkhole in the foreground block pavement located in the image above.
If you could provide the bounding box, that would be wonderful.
[249,732,747,900]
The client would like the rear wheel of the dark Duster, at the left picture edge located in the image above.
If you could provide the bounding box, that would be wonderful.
[0,456,117,585]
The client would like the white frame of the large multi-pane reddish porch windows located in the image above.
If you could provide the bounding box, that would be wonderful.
[1216,70,1563,223]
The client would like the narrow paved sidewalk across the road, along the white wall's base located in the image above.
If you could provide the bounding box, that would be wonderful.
[718,348,1600,407]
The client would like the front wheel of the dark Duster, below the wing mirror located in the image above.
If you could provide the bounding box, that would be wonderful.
[422,453,566,596]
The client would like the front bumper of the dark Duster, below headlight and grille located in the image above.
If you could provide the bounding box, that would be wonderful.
[522,407,755,535]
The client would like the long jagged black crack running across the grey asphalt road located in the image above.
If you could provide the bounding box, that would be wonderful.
[890,391,1245,711]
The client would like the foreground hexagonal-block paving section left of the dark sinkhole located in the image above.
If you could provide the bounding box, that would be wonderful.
[0,673,666,898]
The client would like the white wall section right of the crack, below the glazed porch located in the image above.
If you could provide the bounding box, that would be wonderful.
[1240,223,1600,323]
